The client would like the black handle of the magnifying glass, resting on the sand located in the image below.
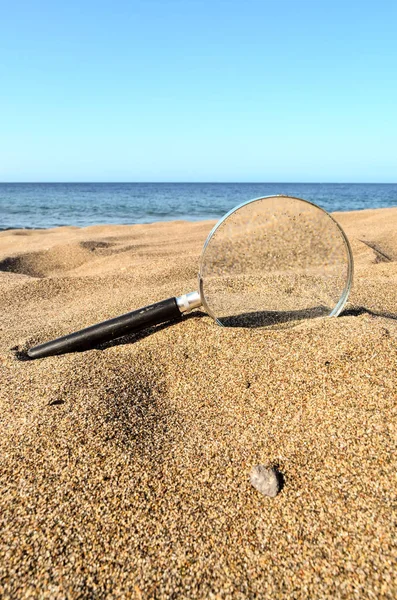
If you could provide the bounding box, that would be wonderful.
[28,298,181,358]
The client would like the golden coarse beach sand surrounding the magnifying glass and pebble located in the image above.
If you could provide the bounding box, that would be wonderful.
[0,208,397,599]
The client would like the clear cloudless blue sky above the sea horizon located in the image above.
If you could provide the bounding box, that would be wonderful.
[0,0,397,182]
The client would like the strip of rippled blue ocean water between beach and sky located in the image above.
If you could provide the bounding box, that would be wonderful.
[0,183,397,230]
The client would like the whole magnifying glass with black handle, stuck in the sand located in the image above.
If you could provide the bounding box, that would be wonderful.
[28,196,353,358]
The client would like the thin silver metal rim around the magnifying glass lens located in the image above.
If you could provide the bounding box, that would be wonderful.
[198,194,354,327]
